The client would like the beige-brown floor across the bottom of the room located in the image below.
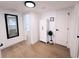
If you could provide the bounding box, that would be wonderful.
[2,41,70,58]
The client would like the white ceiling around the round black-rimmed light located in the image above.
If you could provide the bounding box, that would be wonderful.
[0,1,78,13]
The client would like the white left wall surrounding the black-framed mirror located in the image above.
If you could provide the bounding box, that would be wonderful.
[0,11,24,49]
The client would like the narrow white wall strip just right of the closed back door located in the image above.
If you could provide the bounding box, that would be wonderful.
[66,7,73,48]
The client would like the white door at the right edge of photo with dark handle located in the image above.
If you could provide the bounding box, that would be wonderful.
[70,6,79,58]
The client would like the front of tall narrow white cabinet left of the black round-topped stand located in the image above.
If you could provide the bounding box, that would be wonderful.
[40,20,47,42]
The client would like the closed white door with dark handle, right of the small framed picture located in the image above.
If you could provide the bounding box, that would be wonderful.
[56,11,67,46]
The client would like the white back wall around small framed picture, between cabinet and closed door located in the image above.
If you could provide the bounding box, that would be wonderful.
[39,11,56,43]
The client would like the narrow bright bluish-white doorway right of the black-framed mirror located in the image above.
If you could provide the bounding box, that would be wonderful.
[23,14,31,44]
